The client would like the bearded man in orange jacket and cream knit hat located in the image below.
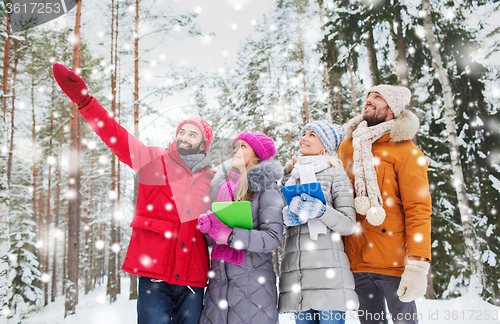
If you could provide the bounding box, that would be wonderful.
[338,85,432,324]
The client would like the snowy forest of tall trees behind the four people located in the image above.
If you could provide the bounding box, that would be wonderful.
[0,0,500,323]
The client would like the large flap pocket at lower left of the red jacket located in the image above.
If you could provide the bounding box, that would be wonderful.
[124,216,178,274]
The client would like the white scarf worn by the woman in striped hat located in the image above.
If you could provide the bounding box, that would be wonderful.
[285,155,332,241]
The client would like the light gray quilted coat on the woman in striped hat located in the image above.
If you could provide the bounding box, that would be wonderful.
[278,168,359,313]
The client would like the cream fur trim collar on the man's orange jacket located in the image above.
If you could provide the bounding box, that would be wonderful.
[344,110,420,143]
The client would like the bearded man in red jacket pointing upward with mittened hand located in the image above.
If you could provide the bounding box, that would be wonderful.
[53,63,213,324]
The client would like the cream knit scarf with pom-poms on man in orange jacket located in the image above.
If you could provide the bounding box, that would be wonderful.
[352,120,394,226]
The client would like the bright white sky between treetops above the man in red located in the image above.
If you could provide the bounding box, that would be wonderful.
[44,0,274,145]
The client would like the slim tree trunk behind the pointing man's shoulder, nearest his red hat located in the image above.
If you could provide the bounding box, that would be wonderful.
[129,0,139,299]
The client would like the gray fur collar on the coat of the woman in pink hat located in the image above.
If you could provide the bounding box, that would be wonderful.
[210,159,283,201]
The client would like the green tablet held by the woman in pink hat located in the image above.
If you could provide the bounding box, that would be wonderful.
[212,201,253,244]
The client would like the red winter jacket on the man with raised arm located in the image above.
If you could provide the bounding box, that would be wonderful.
[80,98,213,287]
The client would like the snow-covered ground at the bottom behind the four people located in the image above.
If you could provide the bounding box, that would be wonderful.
[6,278,500,324]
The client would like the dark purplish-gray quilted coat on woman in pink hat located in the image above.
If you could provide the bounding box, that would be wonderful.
[200,160,285,324]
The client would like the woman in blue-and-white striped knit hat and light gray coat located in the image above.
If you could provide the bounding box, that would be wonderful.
[278,121,358,323]
